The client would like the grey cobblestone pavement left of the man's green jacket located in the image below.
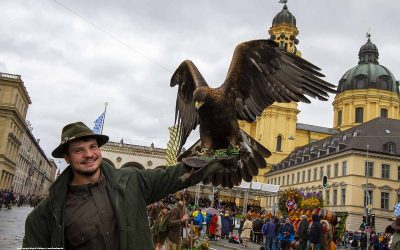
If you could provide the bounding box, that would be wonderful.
[0,206,33,250]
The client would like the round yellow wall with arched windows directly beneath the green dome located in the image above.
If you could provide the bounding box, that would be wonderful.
[332,89,400,131]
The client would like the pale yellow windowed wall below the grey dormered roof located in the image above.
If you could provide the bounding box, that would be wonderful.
[265,151,400,232]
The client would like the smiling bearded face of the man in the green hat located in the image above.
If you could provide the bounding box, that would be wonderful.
[64,138,102,176]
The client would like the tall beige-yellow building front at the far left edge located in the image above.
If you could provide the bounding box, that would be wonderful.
[0,73,31,189]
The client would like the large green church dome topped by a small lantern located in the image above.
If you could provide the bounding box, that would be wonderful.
[337,37,399,93]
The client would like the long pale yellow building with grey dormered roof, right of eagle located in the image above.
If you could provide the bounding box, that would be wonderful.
[266,118,400,232]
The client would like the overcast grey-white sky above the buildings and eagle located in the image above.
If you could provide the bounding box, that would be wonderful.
[0,0,400,168]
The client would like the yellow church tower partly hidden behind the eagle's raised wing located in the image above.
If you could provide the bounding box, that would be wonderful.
[239,0,301,182]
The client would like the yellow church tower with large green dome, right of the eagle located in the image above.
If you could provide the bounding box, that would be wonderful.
[333,34,400,131]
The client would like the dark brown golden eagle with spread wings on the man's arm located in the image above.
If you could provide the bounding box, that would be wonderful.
[170,40,336,187]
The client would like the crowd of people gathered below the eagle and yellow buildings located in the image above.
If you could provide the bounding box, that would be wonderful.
[148,195,400,250]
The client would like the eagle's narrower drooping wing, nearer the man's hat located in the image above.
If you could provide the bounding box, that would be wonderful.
[170,60,208,154]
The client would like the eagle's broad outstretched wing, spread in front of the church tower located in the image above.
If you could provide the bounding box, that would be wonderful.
[220,40,336,122]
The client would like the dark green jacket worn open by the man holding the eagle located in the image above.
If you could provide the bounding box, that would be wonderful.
[22,161,195,250]
